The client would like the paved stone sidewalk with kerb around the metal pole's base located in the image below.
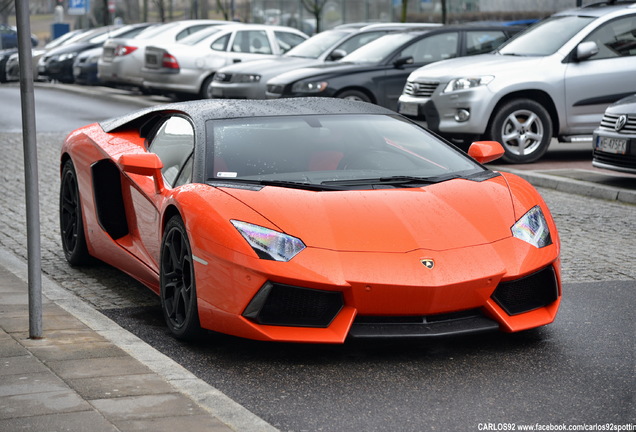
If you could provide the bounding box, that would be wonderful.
[0,250,275,432]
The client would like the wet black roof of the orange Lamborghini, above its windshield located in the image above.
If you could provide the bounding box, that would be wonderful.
[100,97,395,132]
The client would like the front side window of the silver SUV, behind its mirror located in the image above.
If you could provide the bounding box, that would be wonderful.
[585,16,636,60]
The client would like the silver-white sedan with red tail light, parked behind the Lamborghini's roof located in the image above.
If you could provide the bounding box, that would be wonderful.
[142,24,307,99]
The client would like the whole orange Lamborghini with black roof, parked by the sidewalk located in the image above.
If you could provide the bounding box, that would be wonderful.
[60,98,561,343]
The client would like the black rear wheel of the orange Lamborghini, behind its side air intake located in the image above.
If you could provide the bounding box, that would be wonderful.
[60,159,91,266]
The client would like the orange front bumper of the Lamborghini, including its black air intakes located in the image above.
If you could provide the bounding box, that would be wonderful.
[195,238,561,343]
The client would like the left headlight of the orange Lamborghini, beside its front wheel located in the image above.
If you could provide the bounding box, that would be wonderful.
[230,220,305,261]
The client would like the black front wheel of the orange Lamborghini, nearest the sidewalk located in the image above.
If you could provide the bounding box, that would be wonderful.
[160,216,201,340]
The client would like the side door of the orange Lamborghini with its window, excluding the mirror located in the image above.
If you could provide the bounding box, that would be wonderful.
[123,115,194,271]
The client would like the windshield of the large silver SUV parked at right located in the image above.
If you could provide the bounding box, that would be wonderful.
[498,15,594,56]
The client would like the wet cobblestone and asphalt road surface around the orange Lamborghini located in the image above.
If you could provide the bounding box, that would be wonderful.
[0,82,636,431]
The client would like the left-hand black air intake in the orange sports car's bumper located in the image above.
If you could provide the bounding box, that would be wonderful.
[243,282,344,328]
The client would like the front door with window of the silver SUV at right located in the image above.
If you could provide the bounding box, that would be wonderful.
[565,14,636,134]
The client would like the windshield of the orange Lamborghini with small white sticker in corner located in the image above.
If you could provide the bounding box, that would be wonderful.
[206,114,490,190]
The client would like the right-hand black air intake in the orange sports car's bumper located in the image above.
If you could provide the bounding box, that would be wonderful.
[492,266,559,315]
